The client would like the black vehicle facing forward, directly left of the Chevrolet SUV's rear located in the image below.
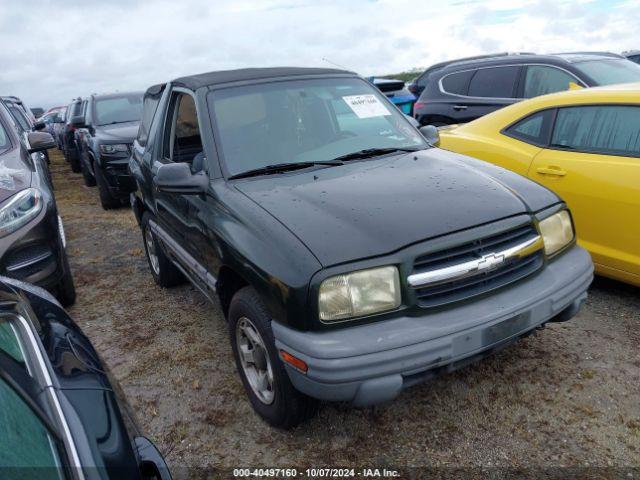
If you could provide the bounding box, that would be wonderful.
[71,92,142,209]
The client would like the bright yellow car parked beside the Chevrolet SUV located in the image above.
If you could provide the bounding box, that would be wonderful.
[436,83,640,286]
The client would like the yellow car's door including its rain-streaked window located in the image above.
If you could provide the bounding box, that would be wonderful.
[528,105,640,285]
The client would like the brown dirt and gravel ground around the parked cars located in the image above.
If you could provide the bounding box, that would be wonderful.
[52,150,640,478]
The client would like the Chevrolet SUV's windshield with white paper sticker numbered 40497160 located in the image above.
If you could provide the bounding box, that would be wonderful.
[209,78,428,175]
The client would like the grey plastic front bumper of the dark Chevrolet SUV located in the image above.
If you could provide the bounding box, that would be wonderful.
[272,246,593,405]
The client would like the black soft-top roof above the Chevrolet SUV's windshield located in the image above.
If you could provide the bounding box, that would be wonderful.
[171,67,355,90]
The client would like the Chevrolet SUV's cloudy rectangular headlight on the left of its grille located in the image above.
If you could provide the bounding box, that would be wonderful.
[318,266,400,322]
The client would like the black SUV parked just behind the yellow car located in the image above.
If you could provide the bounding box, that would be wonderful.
[414,52,640,126]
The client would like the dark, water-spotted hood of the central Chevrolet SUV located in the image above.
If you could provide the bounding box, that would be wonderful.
[236,148,557,267]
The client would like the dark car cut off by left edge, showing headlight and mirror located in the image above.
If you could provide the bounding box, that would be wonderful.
[0,102,76,306]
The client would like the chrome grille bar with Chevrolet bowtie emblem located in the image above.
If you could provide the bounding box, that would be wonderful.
[407,235,544,288]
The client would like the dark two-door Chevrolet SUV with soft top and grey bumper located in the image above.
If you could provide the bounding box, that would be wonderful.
[129,68,593,428]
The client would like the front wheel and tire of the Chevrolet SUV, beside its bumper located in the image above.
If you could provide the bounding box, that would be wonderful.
[228,287,318,429]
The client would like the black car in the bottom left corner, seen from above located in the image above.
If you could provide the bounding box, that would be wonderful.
[0,277,171,480]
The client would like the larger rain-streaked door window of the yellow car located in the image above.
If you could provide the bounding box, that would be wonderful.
[551,105,640,157]
